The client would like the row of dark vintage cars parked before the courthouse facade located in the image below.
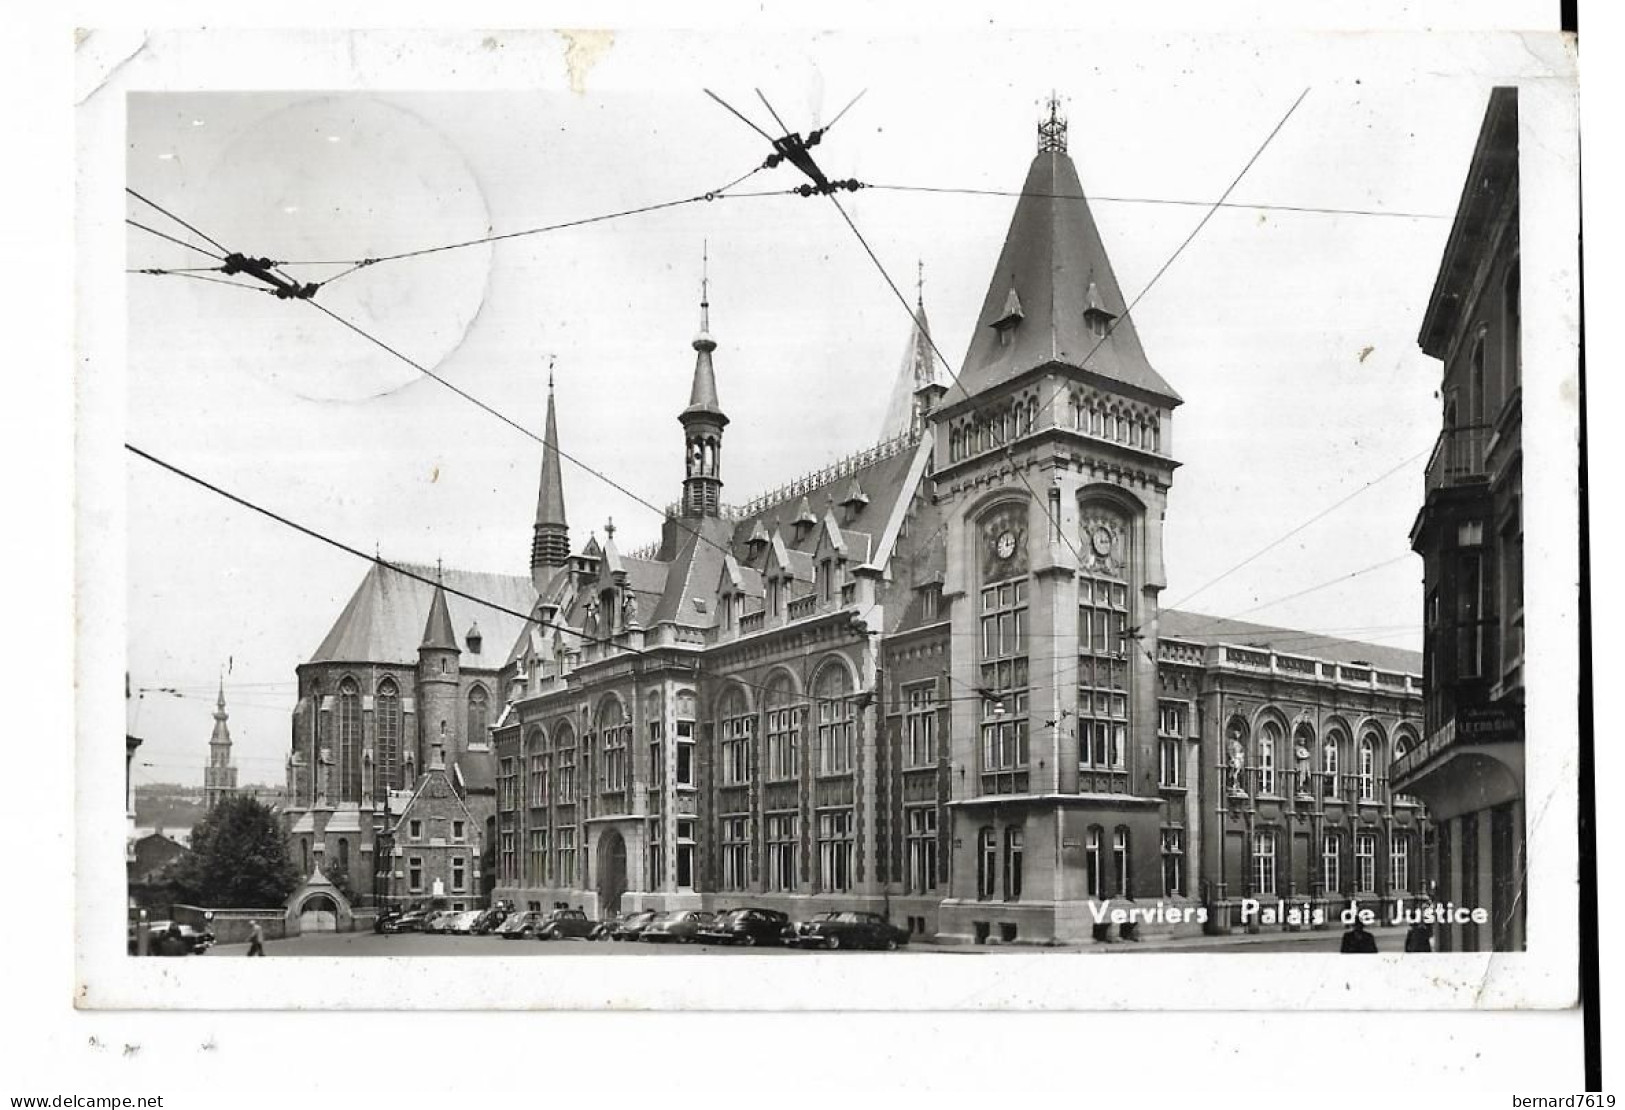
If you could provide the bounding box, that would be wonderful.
[375,907,908,951]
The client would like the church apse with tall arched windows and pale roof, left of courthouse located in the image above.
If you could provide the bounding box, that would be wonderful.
[283,566,536,902]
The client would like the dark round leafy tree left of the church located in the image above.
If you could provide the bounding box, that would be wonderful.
[176,795,299,908]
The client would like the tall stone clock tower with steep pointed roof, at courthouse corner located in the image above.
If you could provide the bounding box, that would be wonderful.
[930,96,1199,936]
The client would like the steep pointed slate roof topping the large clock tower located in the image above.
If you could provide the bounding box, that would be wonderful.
[944,150,1180,405]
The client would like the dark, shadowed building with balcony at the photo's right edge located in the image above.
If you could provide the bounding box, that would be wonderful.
[1389,88,1528,951]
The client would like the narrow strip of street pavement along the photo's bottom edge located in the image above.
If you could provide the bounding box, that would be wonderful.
[210,928,1404,959]
